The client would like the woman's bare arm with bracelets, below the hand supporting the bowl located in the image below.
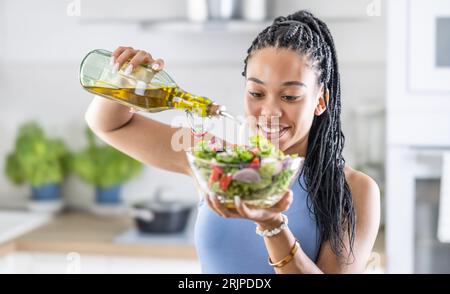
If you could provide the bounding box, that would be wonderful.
[259,172,380,274]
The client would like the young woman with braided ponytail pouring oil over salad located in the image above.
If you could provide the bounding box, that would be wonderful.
[86,11,380,273]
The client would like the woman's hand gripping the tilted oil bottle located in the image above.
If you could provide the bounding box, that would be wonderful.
[111,46,164,74]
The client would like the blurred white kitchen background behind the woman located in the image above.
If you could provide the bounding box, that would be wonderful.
[0,0,450,273]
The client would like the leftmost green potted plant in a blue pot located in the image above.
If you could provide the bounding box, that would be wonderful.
[5,121,69,210]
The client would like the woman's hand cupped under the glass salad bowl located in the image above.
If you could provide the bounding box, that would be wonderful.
[205,190,293,224]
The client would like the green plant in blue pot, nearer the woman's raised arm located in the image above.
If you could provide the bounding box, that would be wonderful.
[69,128,142,205]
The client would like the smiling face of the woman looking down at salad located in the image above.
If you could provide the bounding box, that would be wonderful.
[244,47,325,156]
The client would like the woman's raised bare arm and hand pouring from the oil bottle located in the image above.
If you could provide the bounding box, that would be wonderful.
[85,47,194,175]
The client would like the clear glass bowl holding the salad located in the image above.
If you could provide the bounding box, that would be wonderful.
[186,149,304,208]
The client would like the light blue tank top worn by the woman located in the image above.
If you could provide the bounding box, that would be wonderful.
[195,177,320,274]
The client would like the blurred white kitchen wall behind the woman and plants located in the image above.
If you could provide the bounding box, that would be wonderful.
[0,0,385,207]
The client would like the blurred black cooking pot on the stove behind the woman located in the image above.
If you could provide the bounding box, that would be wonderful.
[132,191,193,233]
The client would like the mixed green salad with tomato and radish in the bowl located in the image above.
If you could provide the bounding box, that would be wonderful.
[188,134,302,208]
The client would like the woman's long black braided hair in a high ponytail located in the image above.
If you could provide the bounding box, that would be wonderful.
[242,10,355,257]
